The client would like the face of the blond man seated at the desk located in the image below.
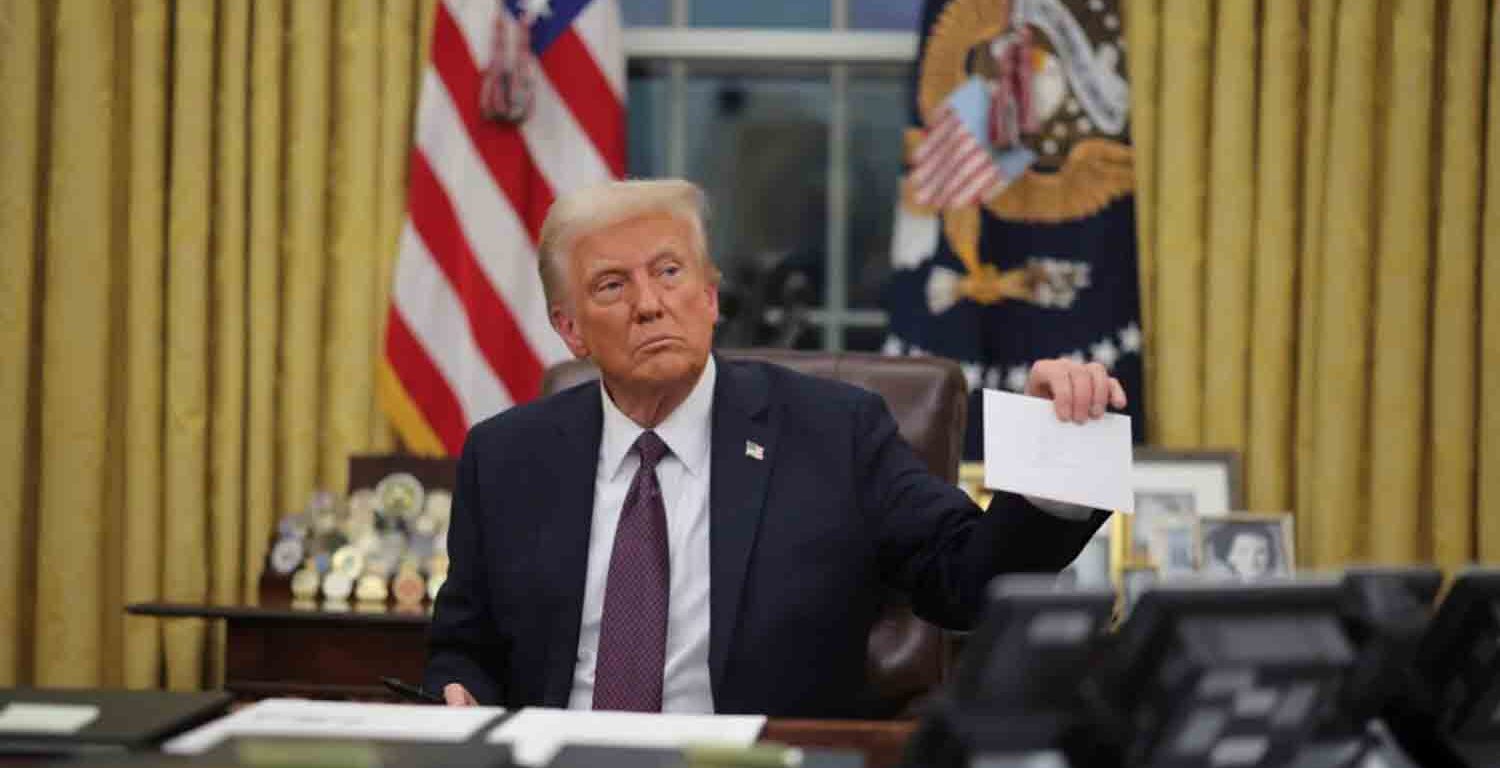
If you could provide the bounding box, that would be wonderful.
[552,213,719,387]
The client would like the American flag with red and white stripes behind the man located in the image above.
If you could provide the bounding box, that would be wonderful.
[380,0,626,455]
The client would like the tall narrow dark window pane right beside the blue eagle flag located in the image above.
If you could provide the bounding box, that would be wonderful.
[846,68,911,309]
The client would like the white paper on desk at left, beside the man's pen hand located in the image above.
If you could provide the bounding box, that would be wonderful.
[162,699,504,755]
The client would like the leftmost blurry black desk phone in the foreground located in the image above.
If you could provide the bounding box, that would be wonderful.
[908,576,1115,767]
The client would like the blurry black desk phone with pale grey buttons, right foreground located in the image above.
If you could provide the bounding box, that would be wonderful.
[1086,581,1355,768]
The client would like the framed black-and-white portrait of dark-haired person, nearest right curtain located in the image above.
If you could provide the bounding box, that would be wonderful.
[1199,513,1296,581]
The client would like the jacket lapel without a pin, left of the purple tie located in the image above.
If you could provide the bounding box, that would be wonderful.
[534,383,605,707]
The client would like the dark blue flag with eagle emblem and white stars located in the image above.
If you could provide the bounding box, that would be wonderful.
[882,0,1145,458]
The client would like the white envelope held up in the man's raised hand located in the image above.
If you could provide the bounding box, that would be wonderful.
[984,390,1136,512]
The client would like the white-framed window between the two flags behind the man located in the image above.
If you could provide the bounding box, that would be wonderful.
[623,0,921,350]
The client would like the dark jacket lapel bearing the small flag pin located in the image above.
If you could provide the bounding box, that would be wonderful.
[708,359,780,698]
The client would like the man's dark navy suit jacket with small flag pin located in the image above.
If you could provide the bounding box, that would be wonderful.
[423,357,1104,717]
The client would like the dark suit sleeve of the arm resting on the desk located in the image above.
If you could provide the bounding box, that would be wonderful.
[423,435,509,704]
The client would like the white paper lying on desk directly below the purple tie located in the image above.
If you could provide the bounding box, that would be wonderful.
[488,707,765,767]
